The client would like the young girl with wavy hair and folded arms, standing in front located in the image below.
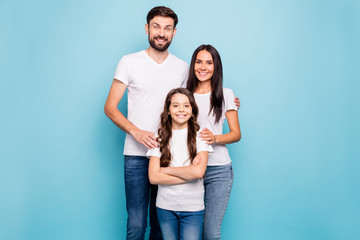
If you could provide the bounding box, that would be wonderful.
[147,88,212,240]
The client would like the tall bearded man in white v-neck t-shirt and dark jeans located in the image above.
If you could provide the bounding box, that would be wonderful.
[105,6,184,239]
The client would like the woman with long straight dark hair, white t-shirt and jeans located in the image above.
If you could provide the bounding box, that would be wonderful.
[187,45,241,239]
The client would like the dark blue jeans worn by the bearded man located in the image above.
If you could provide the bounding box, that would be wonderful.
[124,156,162,240]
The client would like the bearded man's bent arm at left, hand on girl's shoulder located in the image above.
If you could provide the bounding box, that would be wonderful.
[104,79,157,148]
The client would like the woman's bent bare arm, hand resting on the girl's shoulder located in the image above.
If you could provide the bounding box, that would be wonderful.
[200,110,241,144]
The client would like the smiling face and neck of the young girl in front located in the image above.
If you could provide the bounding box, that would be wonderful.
[169,93,192,129]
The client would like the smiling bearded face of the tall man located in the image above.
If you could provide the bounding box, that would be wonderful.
[145,16,176,52]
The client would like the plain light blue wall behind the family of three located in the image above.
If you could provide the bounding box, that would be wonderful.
[0,0,360,240]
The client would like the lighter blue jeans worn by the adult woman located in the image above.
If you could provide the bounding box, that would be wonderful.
[203,163,233,239]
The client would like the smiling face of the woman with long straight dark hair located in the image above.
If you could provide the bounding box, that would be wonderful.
[194,50,214,82]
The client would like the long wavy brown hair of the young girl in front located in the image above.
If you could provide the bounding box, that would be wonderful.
[158,88,200,167]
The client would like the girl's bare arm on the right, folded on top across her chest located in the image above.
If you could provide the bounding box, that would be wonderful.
[160,151,209,181]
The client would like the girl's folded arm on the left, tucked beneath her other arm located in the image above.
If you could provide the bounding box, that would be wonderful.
[149,157,187,185]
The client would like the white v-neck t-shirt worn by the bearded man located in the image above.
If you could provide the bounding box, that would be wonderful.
[114,50,188,156]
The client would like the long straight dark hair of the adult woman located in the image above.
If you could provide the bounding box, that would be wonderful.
[186,44,224,123]
